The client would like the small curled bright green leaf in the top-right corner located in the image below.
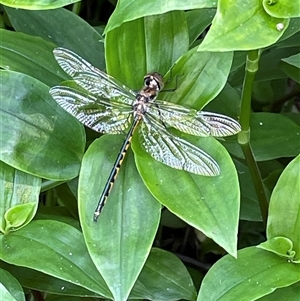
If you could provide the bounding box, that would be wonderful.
[262,0,300,18]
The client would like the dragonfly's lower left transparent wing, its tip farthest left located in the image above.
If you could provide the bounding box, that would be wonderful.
[50,86,133,134]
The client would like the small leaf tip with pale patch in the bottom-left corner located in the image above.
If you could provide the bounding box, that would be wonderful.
[0,269,25,301]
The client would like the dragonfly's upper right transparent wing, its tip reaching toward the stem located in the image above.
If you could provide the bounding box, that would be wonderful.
[147,100,241,137]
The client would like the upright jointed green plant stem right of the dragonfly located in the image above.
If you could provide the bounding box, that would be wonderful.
[238,50,268,225]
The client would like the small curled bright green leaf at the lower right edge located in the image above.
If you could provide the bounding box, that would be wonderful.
[257,236,296,260]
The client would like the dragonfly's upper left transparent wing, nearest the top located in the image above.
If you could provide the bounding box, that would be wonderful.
[53,47,135,104]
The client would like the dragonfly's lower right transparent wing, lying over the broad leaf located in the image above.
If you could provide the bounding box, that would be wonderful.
[139,115,220,176]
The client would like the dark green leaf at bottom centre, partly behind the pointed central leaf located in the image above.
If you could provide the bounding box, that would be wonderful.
[130,248,196,301]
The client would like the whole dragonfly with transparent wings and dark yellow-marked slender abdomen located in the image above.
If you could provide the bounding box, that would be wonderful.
[50,47,241,221]
